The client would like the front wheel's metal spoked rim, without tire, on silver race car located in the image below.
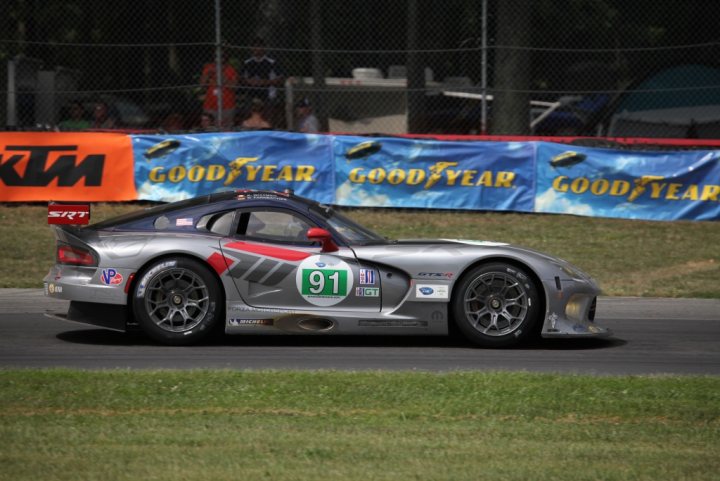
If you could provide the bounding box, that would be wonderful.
[463,272,529,337]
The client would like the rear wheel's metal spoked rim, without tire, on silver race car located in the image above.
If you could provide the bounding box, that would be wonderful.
[145,267,210,332]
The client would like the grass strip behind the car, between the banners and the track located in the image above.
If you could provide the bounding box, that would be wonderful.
[0,204,720,298]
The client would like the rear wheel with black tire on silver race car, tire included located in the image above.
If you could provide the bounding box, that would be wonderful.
[132,257,223,346]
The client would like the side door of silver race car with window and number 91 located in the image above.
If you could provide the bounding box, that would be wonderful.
[221,208,381,312]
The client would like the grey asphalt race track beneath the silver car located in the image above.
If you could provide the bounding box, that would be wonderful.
[0,289,720,375]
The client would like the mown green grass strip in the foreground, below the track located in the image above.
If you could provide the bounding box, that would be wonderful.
[0,370,720,481]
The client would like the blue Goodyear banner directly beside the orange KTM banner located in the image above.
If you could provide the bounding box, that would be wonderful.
[132,131,334,203]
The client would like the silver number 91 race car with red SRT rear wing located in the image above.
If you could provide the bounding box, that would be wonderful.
[44,191,611,347]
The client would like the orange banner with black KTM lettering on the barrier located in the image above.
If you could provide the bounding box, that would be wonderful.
[0,132,137,202]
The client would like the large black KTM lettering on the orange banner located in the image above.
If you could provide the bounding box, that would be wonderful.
[0,145,105,187]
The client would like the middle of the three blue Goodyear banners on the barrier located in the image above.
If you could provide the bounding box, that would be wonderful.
[333,136,534,212]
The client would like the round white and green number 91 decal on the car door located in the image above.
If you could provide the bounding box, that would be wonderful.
[295,256,353,307]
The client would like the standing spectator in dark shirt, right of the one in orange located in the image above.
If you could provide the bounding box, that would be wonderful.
[240,37,284,106]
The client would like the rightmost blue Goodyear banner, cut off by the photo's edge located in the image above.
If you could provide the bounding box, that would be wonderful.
[535,142,720,220]
